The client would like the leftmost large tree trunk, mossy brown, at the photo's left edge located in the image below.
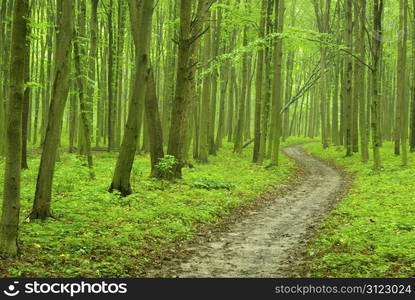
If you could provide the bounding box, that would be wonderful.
[0,0,29,255]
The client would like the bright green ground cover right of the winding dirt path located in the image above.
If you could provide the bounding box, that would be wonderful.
[306,143,415,277]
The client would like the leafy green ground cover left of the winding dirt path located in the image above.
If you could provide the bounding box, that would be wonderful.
[0,139,303,277]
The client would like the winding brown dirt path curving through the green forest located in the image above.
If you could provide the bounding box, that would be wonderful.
[151,146,345,277]
